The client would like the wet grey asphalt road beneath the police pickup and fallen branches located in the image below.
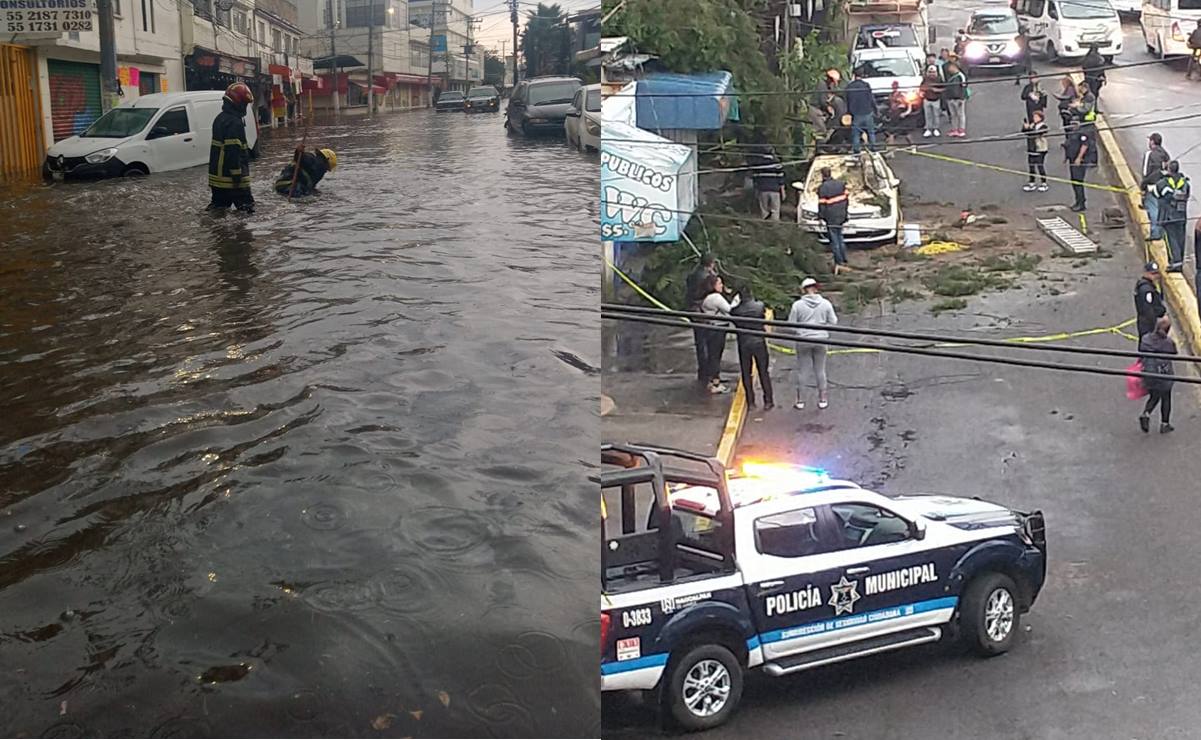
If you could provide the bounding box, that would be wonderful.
[603,4,1201,740]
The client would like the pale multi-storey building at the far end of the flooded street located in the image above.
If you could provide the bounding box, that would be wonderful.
[408,0,475,91]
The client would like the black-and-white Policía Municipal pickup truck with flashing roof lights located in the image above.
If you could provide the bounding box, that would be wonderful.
[601,444,1046,730]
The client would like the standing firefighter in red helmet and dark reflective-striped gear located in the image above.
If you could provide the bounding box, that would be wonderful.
[209,82,255,214]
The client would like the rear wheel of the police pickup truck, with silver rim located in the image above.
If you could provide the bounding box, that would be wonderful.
[663,644,742,732]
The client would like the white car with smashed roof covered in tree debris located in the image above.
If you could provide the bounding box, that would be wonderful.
[793,151,901,245]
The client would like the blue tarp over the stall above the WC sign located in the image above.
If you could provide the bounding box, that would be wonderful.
[635,72,739,131]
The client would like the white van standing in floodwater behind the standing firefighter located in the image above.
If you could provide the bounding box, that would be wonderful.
[42,90,258,180]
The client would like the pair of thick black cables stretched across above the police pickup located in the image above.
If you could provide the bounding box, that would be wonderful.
[601,310,1201,384]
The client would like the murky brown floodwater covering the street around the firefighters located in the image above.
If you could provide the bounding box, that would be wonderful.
[0,106,599,738]
